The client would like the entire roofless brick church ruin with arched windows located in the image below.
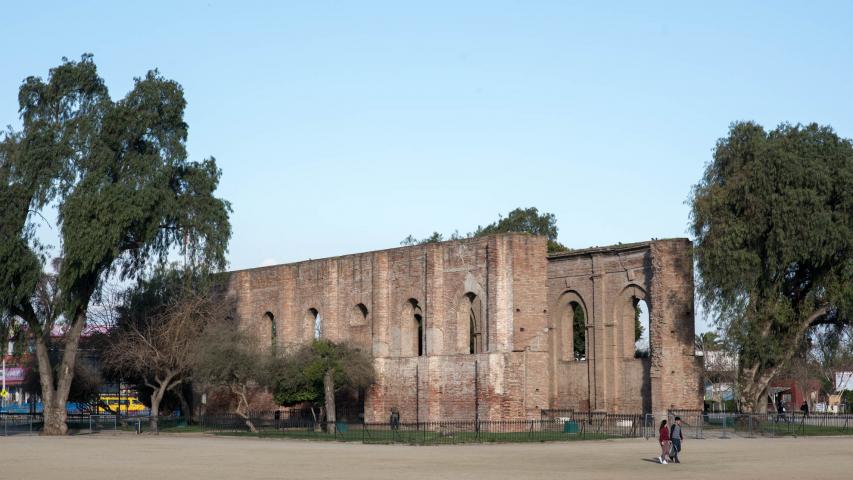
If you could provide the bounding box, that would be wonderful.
[228,234,701,422]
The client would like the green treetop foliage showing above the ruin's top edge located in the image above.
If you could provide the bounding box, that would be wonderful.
[400,207,569,252]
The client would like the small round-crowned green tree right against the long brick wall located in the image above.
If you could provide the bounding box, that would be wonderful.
[273,340,376,432]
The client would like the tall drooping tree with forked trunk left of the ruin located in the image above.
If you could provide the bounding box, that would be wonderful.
[0,55,231,435]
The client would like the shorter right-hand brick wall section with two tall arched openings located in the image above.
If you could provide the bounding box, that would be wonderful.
[548,239,701,413]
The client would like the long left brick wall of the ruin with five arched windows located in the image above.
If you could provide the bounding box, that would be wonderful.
[229,234,548,421]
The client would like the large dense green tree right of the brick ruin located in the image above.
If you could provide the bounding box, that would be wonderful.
[691,122,853,411]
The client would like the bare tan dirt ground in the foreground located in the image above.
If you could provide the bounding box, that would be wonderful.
[0,433,853,480]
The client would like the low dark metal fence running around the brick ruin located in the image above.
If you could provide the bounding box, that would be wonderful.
[10,409,853,444]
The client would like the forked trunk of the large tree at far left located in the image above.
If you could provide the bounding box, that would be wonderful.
[35,311,86,435]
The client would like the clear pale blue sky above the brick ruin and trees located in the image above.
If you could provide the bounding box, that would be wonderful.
[0,0,853,330]
